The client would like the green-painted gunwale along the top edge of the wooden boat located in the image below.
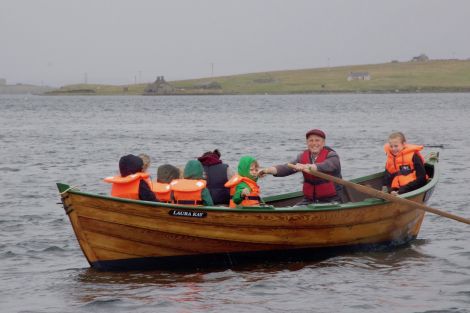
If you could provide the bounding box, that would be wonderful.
[57,159,439,213]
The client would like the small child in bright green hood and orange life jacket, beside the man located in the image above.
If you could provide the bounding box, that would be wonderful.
[225,156,260,208]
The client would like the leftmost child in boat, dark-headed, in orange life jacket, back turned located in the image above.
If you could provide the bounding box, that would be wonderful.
[104,154,157,201]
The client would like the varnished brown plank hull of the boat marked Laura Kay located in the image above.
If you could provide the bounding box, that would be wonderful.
[58,188,434,269]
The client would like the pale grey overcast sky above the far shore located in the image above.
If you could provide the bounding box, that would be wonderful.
[0,0,470,86]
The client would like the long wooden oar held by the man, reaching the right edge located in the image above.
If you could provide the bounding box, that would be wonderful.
[288,164,470,225]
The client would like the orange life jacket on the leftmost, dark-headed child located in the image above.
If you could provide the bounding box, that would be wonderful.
[104,172,152,200]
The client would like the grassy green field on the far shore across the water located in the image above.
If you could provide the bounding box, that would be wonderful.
[46,60,470,95]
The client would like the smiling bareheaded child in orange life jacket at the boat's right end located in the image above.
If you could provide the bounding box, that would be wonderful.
[382,132,426,195]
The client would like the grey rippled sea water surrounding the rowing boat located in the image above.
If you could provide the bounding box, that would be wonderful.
[0,93,470,313]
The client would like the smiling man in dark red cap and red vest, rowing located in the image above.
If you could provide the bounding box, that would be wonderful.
[259,129,343,205]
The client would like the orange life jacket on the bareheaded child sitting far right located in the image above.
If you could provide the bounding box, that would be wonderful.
[384,143,424,190]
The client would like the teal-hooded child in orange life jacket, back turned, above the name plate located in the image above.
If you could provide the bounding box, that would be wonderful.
[170,160,214,206]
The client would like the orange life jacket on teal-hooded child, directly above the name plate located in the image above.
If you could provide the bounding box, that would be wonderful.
[170,179,206,205]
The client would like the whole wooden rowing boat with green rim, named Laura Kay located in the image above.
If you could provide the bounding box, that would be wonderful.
[57,159,438,270]
